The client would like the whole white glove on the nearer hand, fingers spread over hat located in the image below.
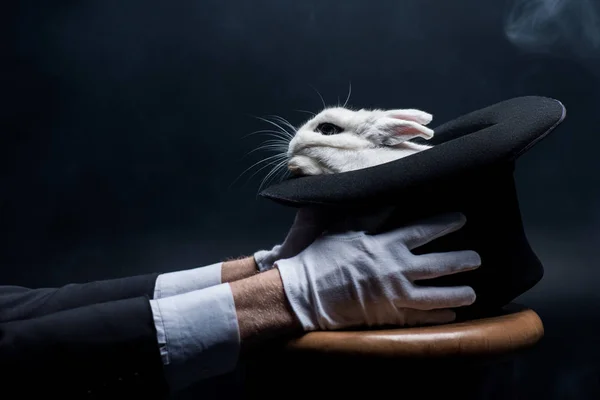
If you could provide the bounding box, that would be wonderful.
[275,214,481,331]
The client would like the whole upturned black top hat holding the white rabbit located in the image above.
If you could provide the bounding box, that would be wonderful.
[260,96,565,318]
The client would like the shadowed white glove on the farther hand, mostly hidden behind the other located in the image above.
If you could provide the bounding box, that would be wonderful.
[254,208,330,272]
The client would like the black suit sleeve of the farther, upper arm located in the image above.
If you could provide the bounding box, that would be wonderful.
[0,274,158,323]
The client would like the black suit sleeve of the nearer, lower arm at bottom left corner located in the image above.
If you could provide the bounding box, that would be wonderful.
[0,296,168,399]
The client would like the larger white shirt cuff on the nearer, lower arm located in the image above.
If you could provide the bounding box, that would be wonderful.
[150,283,240,392]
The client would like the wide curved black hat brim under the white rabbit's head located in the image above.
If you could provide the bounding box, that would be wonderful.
[260,96,566,207]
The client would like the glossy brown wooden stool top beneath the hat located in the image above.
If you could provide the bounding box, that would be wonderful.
[284,304,544,358]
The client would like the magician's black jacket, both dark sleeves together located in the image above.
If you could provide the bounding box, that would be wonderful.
[0,274,167,399]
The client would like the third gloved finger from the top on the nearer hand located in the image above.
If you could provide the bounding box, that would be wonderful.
[402,286,477,310]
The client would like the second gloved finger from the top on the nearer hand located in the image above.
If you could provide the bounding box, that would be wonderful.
[405,250,481,281]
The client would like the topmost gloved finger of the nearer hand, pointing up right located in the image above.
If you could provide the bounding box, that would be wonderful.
[377,213,467,250]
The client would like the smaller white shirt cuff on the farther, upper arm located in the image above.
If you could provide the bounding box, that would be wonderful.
[154,262,223,299]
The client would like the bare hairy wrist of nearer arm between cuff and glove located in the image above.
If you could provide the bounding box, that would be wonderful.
[230,268,302,348]
